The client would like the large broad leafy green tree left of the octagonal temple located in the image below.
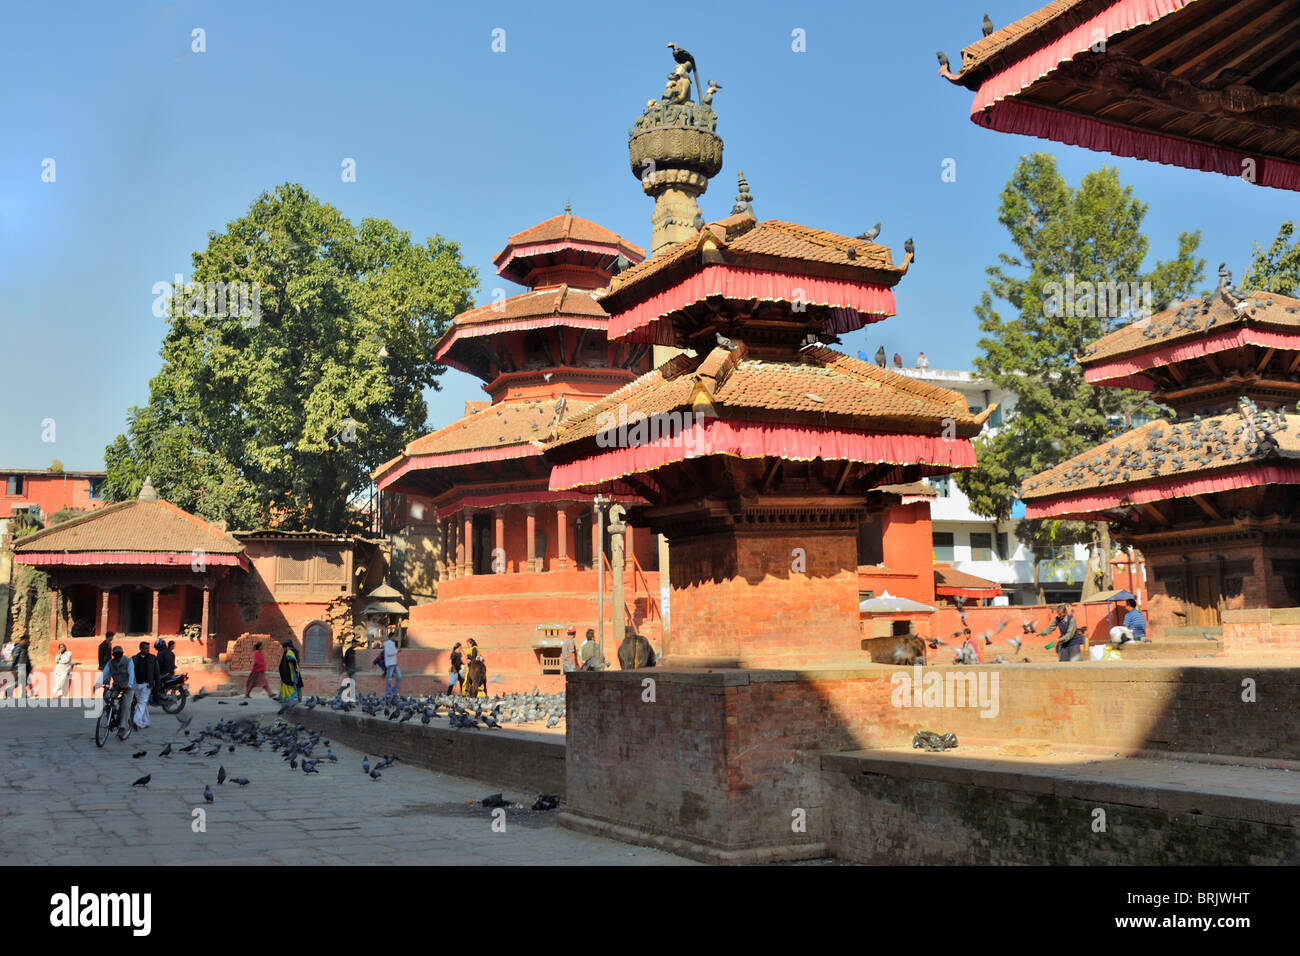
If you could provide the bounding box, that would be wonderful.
[104,183,478,531]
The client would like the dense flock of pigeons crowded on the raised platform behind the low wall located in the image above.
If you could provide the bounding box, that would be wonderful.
[296,687,564,730]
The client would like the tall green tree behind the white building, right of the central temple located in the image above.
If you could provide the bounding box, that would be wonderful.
[957,153,1205,593]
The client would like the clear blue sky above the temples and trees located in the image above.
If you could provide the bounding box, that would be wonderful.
[0,0,1297,468]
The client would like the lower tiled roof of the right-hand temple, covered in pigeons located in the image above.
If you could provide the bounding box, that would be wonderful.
[1021,410,1300,501]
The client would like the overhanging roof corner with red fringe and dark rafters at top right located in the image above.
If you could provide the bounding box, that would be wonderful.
[940,0,1300,190]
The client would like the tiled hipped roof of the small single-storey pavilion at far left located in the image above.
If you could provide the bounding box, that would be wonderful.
[14,499,244,554]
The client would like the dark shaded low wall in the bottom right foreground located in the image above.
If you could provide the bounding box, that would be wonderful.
[823,752,1300,866]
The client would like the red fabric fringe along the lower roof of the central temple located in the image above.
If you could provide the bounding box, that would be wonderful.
[550,419,975,490]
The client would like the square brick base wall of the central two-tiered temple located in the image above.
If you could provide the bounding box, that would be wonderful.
[664,531,861,666]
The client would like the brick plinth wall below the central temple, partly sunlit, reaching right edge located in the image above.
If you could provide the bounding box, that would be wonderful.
[562,663,1300,862]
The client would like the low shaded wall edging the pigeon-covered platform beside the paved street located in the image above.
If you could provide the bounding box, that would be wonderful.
[291,708,564,801]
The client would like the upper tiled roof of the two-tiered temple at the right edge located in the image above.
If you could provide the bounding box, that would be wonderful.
[1079,291,1300,365]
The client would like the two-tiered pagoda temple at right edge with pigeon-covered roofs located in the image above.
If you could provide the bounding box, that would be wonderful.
[1021,287,1300,637]
